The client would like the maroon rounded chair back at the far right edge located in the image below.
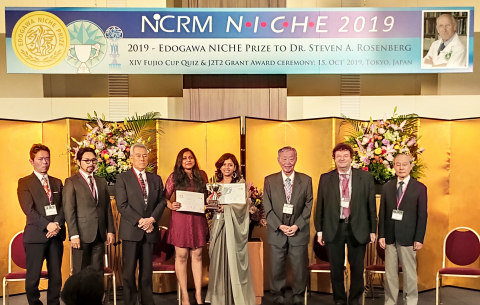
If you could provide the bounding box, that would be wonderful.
[443,227,480,268]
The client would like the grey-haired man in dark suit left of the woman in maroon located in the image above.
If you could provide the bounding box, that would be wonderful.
[115,143,167,305]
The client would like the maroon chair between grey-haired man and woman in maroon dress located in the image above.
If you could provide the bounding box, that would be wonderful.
[153,226,182,305]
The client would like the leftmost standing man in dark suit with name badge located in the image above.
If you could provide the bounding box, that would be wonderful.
[17,144,66,305]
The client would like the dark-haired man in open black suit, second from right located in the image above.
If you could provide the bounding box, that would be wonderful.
[315,143,377,305]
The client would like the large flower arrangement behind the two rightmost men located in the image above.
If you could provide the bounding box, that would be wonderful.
[341,107,426,184]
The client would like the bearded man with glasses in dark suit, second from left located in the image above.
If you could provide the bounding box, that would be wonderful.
[63,147,115,273]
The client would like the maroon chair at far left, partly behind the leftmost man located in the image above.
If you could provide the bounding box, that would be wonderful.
[3,231,48,305]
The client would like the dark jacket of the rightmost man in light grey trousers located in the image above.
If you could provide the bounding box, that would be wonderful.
[378,177,428,246]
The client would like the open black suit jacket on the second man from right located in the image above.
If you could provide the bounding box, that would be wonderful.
[315,168,377,244]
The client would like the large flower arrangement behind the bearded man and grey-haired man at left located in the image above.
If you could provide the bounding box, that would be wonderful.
[67,112,158,183]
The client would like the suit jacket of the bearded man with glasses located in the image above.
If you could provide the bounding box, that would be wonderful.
[62,173,115,243]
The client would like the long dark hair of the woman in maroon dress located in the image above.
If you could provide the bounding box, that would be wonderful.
[173,148,207,193]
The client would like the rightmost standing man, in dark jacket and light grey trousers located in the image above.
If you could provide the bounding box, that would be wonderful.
[378,154,427,305]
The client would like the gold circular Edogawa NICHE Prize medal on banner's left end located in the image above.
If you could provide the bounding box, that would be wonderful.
[12,11,70,70]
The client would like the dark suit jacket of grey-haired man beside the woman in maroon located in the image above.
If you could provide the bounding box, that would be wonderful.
[115,168,167,243]
